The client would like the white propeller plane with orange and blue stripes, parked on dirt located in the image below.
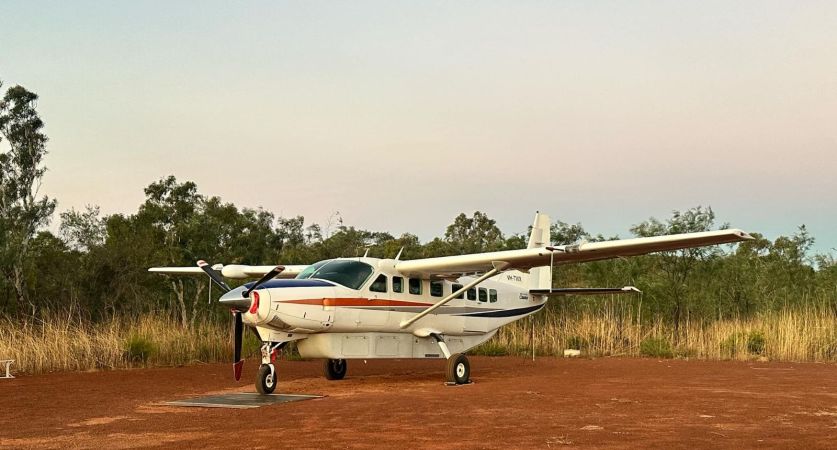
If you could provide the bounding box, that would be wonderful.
[149,213,752,394]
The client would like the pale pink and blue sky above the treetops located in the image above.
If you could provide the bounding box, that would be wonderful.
[0,1,837,251]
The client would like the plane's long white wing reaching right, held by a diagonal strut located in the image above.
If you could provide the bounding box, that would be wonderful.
[395,229,753,277]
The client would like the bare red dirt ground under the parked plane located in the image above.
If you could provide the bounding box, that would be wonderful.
[0,357,837,449]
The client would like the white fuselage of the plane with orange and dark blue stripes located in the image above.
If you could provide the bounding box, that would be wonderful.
[227,258,546,358]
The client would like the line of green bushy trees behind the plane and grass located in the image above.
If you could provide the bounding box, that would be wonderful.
[0,83,837,327]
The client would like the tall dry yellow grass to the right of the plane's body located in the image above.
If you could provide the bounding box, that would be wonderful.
[477,303,837,362]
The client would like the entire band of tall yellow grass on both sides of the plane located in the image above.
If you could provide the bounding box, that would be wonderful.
[0,302,837,373]
